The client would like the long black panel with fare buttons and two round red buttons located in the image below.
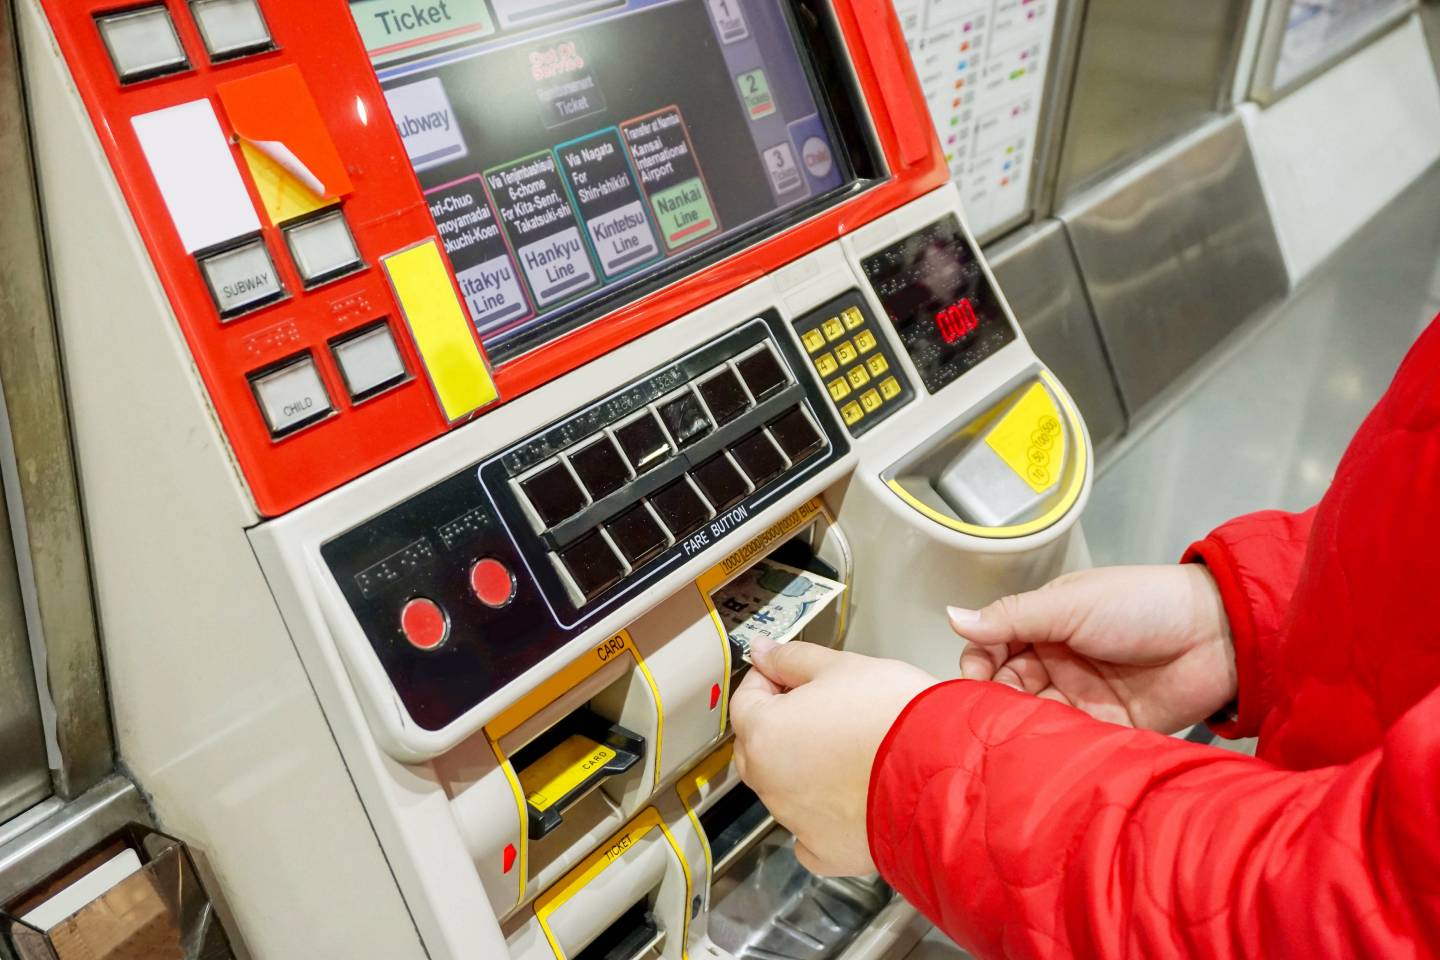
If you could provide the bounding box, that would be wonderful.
[321,312,850,730]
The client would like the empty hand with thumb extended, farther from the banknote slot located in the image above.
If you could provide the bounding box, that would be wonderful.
[949,563,1236,733]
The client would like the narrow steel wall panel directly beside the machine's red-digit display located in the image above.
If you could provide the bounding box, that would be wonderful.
[986,220,1125,448]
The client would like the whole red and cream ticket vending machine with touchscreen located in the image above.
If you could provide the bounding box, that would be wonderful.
[19,0,1093,960]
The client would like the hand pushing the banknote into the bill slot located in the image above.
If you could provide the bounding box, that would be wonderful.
[730,640,936,877]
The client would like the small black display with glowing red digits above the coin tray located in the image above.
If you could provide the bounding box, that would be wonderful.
[861,214,1015,393]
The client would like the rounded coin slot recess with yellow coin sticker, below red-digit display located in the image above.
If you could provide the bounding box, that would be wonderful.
[884,371,1086,537]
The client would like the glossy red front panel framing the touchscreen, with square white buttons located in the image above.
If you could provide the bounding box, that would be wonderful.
[43,0,946,515]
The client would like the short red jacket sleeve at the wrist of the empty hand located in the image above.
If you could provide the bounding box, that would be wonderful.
[1185,507,1315,737]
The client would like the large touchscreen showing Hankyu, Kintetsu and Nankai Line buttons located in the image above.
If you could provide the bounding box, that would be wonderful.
[358,0,858,363]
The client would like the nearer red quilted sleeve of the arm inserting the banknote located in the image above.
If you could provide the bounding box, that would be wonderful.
[868,679,1440,960]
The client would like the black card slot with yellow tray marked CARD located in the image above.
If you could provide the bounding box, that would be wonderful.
[511,705,645,841]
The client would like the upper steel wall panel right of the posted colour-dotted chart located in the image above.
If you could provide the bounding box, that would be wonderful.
[1057,0,1248,204]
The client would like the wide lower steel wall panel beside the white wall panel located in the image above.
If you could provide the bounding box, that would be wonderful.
[1060,117,1289,419]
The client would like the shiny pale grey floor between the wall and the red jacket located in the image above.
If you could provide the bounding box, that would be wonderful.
[1084,166,1440,564]
